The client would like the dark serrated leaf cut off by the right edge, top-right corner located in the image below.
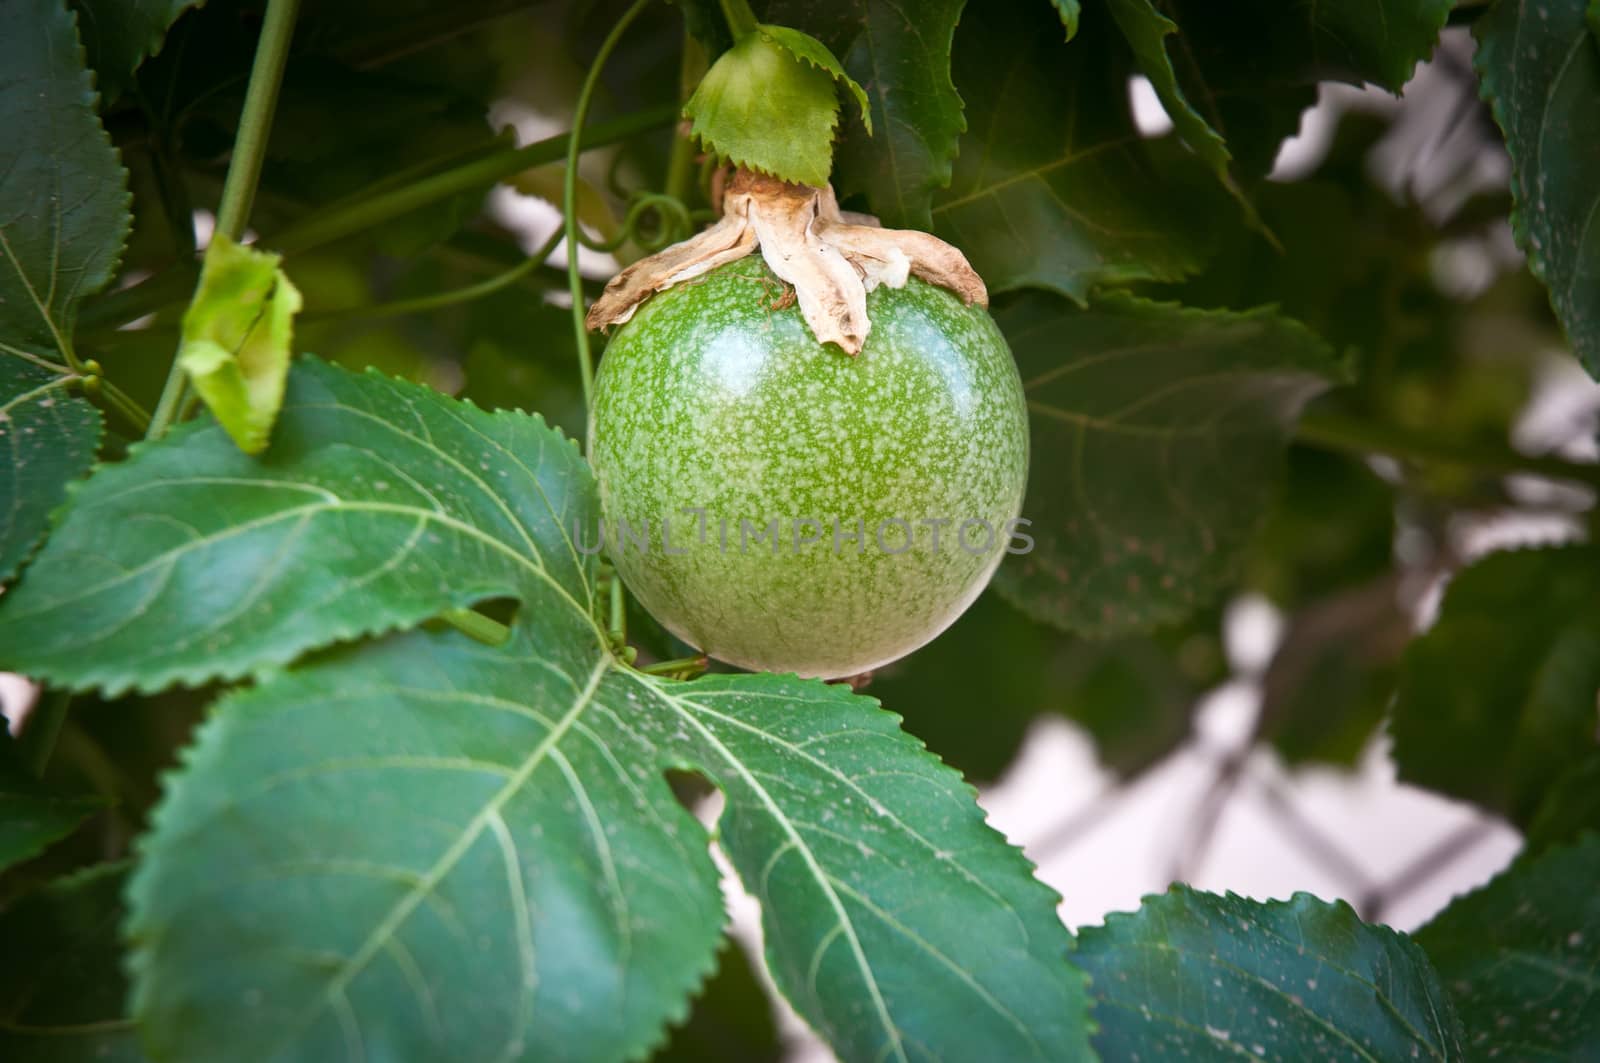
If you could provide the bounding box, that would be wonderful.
[1474,0,1600,376]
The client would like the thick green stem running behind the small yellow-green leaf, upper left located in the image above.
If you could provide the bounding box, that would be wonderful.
[144,0,299,439]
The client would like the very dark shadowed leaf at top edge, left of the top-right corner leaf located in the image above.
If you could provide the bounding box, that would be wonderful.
[1162,0,1454,176]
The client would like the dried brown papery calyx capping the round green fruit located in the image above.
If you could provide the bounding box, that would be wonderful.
[587,170,989,354]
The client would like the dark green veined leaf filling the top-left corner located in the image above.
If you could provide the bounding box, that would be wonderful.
[0,0,130,362]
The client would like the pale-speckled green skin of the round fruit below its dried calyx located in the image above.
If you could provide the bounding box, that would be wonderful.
[578,255,1027,677]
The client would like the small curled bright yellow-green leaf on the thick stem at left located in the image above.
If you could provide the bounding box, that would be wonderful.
[178,232,301,455]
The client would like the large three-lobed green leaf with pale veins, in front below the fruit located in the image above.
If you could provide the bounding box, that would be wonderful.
[84,360,1086,1060]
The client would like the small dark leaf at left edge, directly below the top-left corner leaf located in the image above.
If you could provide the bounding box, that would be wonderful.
[0,357,101,583]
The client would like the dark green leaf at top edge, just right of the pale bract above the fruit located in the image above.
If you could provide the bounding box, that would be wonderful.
[766,0,966,229]
